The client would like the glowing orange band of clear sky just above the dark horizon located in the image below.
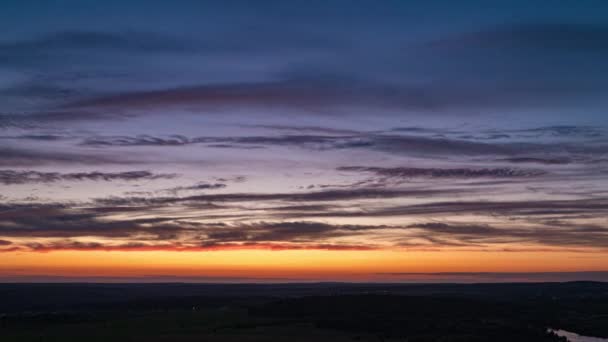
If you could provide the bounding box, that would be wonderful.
[0,250,608,281]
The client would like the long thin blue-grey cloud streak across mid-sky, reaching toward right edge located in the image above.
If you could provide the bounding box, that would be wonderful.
[76,134,592,157]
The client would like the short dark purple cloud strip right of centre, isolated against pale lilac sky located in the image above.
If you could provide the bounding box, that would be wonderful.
[337,166,546,178]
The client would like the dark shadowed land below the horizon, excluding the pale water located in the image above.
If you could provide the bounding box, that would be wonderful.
[0,282,608,342]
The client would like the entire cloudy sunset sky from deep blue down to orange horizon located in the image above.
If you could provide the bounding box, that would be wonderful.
[0,0,608,282]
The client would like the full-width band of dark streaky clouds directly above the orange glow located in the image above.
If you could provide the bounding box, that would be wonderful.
[0,195,608,251]
